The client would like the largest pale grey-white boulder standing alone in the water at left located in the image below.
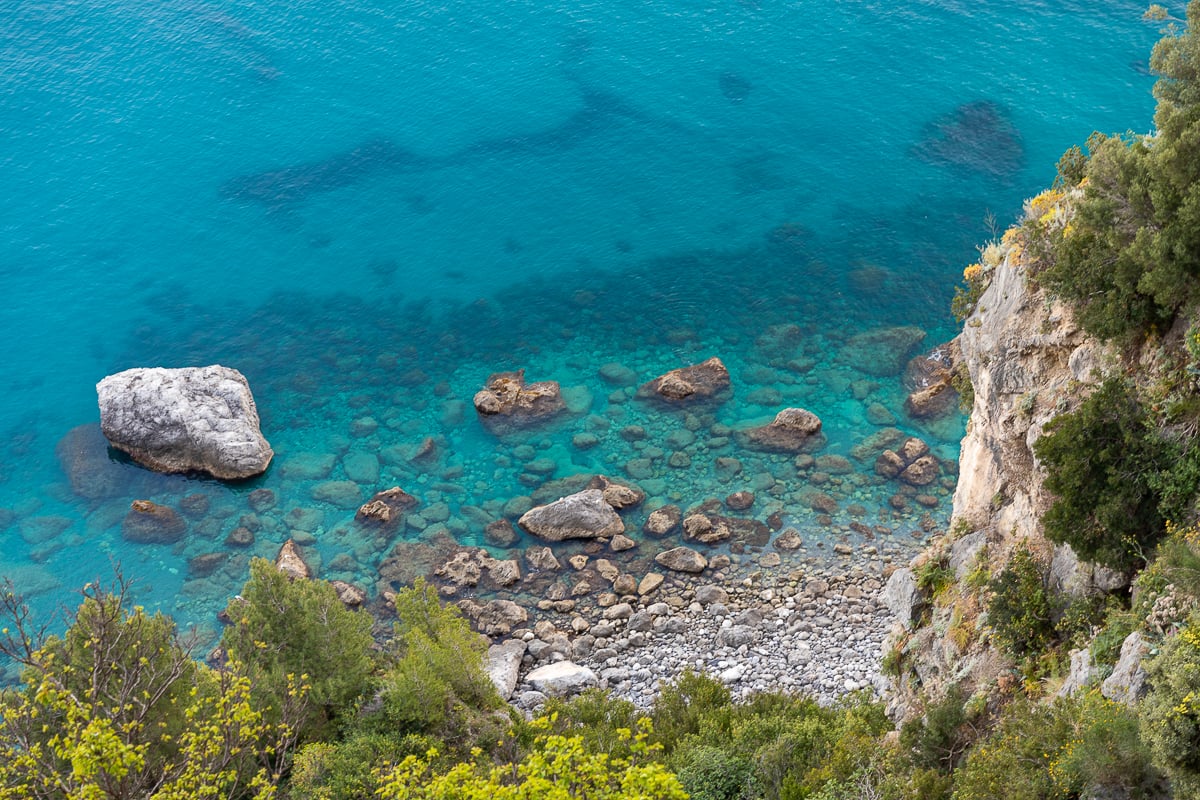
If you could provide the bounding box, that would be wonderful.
[96,365,275,480]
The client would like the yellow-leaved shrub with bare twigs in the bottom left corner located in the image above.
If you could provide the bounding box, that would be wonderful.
[0,578,305,800]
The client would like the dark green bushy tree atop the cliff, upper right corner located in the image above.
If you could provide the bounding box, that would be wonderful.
[1040,0,1200,339]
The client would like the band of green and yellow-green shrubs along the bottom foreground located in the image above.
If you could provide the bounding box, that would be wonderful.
[0,546,1200,800]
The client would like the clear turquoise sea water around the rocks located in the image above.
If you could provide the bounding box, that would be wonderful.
[0,0,1178,662]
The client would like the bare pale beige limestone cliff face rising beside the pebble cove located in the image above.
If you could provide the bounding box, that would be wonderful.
[886,237,1108,718]
